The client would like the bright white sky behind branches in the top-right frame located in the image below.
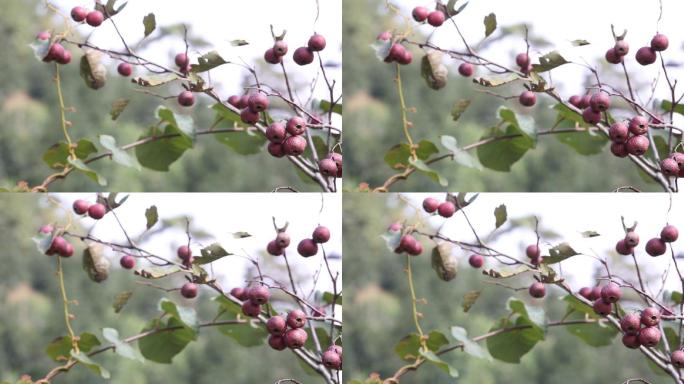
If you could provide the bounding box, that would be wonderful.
[392,0,684,121]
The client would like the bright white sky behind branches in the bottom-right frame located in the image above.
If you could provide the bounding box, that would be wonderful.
[398,193,684,304]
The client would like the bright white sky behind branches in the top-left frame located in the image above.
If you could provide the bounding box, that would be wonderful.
[46,0,342,119]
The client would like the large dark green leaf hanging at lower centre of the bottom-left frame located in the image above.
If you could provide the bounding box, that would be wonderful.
[138,317,197,364]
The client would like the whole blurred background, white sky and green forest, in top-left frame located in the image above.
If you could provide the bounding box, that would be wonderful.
[0,0,342,192]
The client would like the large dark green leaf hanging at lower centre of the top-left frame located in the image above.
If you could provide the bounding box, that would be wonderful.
[135,125,192,172]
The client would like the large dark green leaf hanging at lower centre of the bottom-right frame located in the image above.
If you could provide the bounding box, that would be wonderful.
[487,316,544,363]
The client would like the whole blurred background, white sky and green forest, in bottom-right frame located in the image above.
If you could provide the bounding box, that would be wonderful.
[343,193,684,384]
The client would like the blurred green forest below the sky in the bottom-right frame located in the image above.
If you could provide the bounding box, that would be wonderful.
[343,194,670,384]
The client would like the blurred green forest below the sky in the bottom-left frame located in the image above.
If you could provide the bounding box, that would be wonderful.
[0,194,319,384]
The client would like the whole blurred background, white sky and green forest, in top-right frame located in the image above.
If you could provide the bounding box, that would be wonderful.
[343,0,684,192]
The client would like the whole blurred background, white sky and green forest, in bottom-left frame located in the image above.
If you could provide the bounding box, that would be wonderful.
[0,194,342,384]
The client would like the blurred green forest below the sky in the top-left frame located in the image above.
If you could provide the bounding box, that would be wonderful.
[0,0,318,192]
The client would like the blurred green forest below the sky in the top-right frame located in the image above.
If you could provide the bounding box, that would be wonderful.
[343,0,659,192]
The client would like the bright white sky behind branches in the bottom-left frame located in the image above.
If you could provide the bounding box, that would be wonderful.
[52,193,342,302]
